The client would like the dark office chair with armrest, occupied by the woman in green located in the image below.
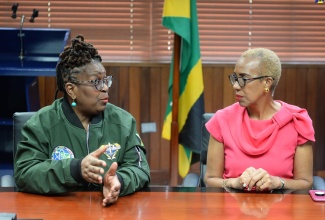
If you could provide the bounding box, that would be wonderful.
[0,112,35,187]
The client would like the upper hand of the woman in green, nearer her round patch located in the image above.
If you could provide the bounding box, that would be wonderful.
[81,146,107,184]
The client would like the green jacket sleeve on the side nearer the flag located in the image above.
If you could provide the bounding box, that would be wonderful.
[117,119,150,196]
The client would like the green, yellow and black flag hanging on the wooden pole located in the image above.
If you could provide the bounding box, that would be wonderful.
[162,0,204,178]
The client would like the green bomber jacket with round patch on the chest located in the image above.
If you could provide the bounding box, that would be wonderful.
[14,98,150,196]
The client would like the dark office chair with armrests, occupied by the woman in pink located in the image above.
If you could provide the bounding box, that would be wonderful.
[182,113,325,190]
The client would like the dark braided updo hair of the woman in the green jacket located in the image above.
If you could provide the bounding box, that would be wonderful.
[54,35,102,99]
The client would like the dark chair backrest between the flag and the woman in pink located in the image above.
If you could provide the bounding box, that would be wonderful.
[200,113,214,187]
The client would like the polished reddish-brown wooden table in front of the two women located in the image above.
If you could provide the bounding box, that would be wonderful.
[0,187,325,220]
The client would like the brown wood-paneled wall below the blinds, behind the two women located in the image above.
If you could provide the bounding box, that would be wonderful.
[39,63,325,185]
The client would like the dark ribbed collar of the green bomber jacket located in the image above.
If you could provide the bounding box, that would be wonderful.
[62,98,104,129]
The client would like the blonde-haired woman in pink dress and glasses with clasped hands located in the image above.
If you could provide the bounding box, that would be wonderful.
[204,48,315,191]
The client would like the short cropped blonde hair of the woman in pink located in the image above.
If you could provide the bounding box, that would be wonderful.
[239,48,282,92]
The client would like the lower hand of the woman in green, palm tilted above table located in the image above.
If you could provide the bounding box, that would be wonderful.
[103,162,121,206]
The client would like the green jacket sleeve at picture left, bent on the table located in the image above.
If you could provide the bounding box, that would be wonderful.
[14,120,82,194]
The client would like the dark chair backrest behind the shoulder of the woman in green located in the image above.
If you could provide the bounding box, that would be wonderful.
[13,112,35,157]
